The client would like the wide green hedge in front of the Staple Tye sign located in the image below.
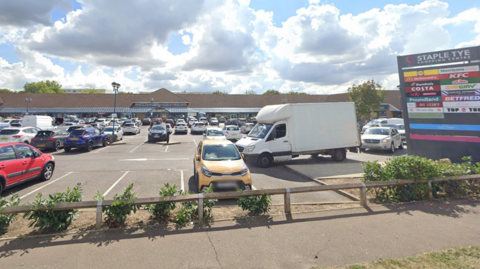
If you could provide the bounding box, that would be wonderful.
[363,156,480,203]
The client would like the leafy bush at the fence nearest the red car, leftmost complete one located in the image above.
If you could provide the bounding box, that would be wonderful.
[23,183,82,231]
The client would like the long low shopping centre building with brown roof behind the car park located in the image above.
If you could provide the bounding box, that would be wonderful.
[0,88,401,118]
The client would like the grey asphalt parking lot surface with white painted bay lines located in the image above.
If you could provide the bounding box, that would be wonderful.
[3,126,406,205]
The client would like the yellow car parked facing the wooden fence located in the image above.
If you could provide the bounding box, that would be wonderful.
[193,140,252,191]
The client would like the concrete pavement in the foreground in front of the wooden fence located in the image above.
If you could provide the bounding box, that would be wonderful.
[0,200,480,269]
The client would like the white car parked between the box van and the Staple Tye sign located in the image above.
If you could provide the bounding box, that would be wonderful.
[361,127,403,153]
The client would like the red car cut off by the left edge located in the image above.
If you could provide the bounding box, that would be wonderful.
[0,143,55,194]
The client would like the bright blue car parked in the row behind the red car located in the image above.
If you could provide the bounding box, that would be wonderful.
[63,128,110,152]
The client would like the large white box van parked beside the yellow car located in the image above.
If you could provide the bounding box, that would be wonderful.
[236,102,360,167]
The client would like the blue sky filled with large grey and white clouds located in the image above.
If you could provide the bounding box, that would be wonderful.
[0,0,480,94]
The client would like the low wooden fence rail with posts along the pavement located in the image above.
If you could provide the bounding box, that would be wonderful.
[0,175,480,228]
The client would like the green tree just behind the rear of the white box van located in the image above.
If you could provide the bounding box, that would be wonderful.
[348,79,387,120]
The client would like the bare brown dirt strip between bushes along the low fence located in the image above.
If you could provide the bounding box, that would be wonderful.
[0,203,359,239]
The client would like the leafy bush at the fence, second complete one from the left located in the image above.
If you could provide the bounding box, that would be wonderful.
[95,184,140,228]
